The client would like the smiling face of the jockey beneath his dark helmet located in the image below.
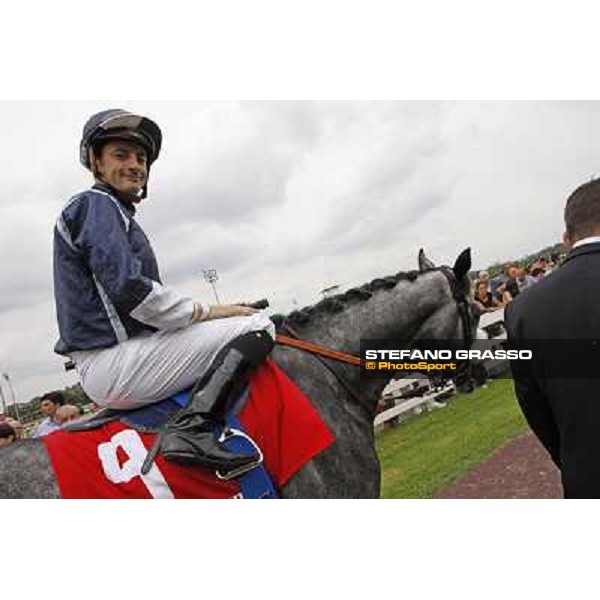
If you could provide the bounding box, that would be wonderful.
[96,140,148,202]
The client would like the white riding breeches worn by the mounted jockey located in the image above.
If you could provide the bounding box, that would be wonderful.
[72,313,275,409]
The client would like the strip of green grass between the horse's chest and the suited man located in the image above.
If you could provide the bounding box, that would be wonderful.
[377,379,527,498]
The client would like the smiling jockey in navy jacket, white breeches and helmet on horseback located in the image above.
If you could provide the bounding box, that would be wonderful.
[54,109,275,472]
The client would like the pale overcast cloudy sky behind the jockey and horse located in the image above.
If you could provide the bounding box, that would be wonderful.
[0,101,600,401]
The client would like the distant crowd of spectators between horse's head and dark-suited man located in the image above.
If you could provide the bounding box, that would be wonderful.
[473,253,565,313]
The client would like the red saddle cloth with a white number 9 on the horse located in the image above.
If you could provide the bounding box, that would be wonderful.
[42,361,334,499]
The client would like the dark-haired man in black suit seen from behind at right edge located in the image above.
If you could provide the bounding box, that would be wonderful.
[505,179,600,498]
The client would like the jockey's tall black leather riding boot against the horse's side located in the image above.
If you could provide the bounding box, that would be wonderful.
[151,331,273,473]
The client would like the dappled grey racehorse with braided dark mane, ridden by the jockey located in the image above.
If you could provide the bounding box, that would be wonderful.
[0,249,477,498]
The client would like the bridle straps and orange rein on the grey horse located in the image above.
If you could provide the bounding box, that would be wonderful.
[276,267,474,406]
